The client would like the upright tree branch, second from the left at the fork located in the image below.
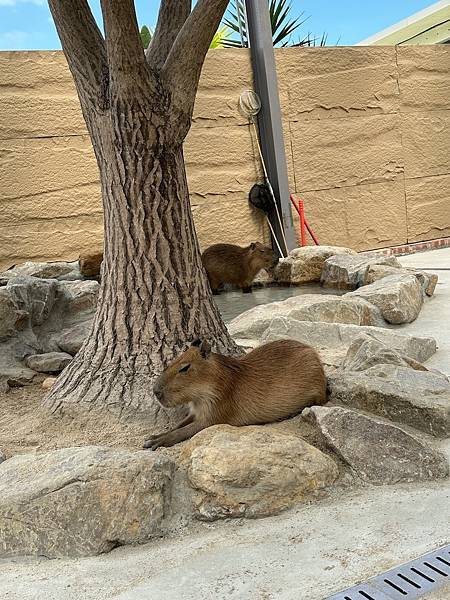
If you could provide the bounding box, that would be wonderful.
[101,0,147,90]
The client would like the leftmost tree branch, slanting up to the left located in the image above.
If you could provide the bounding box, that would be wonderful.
[48,0,108,111]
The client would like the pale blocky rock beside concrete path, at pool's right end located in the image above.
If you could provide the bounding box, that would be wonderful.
[345,275,423,324]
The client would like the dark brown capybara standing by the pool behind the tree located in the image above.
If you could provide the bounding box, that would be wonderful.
[202,242,278,294]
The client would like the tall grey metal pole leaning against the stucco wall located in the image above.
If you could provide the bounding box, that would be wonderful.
[245,0,297,250]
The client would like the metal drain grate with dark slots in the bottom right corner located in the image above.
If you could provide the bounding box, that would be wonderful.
[327,545,450,600]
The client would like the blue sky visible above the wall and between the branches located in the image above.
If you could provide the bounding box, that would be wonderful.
[0,0,442,50]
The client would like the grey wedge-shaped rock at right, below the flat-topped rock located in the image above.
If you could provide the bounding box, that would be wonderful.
[303,406,449,485]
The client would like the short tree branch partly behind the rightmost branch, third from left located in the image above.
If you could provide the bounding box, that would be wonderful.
[146,0,191,69]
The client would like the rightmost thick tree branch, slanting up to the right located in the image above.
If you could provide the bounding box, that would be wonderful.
[163,0,229,115]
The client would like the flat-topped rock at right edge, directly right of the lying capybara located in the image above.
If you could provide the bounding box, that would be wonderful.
[328,365,450,437]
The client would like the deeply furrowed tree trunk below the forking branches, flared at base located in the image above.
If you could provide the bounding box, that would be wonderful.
[46,119,236,428]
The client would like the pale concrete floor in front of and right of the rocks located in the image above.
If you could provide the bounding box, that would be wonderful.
[0,249,450,600]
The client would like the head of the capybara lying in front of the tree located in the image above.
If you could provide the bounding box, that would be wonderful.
[153,340,214,407]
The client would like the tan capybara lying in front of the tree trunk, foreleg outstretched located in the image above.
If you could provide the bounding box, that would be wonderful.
[144,340,327,450]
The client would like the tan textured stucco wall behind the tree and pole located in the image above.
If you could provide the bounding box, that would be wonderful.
[0,46,450,268]
